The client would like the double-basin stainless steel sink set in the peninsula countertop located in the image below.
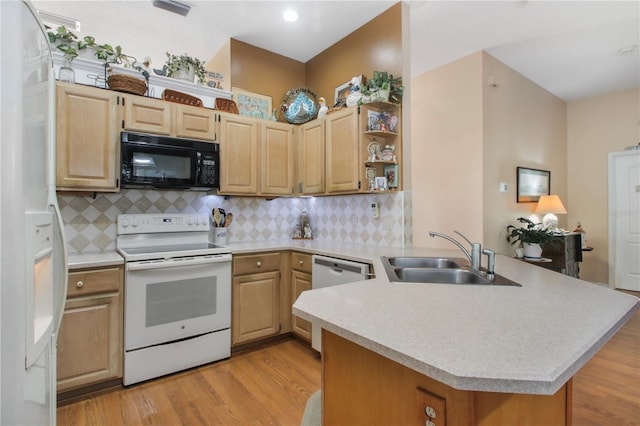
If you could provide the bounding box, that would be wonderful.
[381,256,520,287]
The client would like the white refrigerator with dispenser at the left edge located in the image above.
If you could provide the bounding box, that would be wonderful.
[0,1,67,425]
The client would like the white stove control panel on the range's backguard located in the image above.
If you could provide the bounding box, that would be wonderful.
[117,213,210,235]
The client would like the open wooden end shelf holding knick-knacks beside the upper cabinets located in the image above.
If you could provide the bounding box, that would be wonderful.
[360,102,402,192]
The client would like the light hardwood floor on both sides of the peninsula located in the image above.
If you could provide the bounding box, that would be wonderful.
[58,302,640,426]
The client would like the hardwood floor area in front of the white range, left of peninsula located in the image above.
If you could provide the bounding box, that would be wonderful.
[57,338,320,426]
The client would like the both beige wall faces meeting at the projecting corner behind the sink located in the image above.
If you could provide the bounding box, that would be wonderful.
[411,52,567,254]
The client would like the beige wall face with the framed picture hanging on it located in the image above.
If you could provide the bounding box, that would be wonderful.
[482,53,573,255]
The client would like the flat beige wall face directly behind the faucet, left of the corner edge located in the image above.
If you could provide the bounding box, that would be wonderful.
[405,53,483,248]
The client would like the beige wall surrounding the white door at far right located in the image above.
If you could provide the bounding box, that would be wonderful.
[566,88,640,283]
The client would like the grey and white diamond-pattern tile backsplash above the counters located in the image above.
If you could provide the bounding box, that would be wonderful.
[58,189,412,254]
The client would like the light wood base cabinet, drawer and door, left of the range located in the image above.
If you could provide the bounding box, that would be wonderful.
[57,266,123,393]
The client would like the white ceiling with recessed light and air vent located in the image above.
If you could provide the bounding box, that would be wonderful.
[33,0,640,101]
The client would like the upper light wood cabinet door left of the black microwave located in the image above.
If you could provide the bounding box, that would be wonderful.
[56,83,120,191]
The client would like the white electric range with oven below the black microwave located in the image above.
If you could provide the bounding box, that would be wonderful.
[116,213,231,385]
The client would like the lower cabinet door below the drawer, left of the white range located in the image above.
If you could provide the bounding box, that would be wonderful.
[57,293,123,392]
